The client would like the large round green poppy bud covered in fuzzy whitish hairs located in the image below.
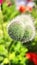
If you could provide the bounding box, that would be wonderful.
[8,14,35,42]
